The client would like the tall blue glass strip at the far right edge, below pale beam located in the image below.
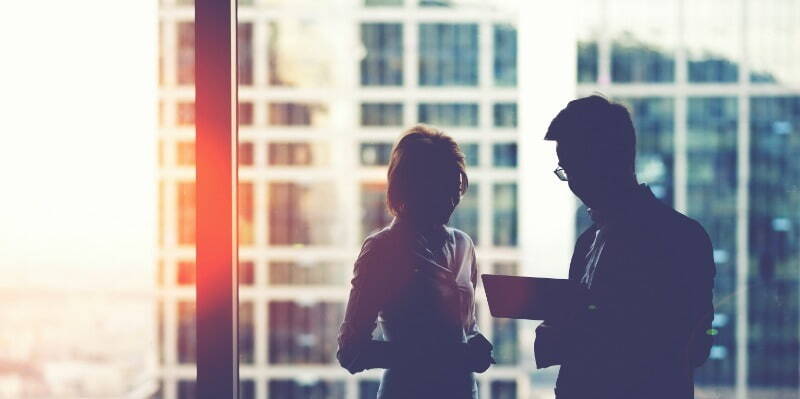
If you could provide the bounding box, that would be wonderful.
[747,95,800,389]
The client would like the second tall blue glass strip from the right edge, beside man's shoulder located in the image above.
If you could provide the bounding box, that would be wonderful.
[687,97,738,385]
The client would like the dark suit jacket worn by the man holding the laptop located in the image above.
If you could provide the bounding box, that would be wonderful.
[534,185,715,399]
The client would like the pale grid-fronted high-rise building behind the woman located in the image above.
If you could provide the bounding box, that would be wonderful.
[157,0,532,399]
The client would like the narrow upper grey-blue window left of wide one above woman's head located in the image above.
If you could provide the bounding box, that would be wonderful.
[361,23,403,86]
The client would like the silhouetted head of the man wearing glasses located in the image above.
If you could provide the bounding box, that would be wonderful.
[545,95,636,208]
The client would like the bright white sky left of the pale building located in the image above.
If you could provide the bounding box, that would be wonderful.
[0,0,158,289]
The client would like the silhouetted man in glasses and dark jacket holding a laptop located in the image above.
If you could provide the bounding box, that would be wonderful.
[534,96,715,399]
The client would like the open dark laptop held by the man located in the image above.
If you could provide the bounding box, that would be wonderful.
[481,274,583,320]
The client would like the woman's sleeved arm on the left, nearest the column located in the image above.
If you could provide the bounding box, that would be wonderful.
[336,238,395,374]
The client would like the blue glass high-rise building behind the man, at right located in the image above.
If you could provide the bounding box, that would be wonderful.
[576,0,800,398]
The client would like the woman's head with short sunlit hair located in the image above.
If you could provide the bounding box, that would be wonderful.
[386,125,469,224]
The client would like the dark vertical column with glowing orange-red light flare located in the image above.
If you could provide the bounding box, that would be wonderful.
[195,0,239,399]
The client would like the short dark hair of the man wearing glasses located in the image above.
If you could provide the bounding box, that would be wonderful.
[544,95,636,172]
